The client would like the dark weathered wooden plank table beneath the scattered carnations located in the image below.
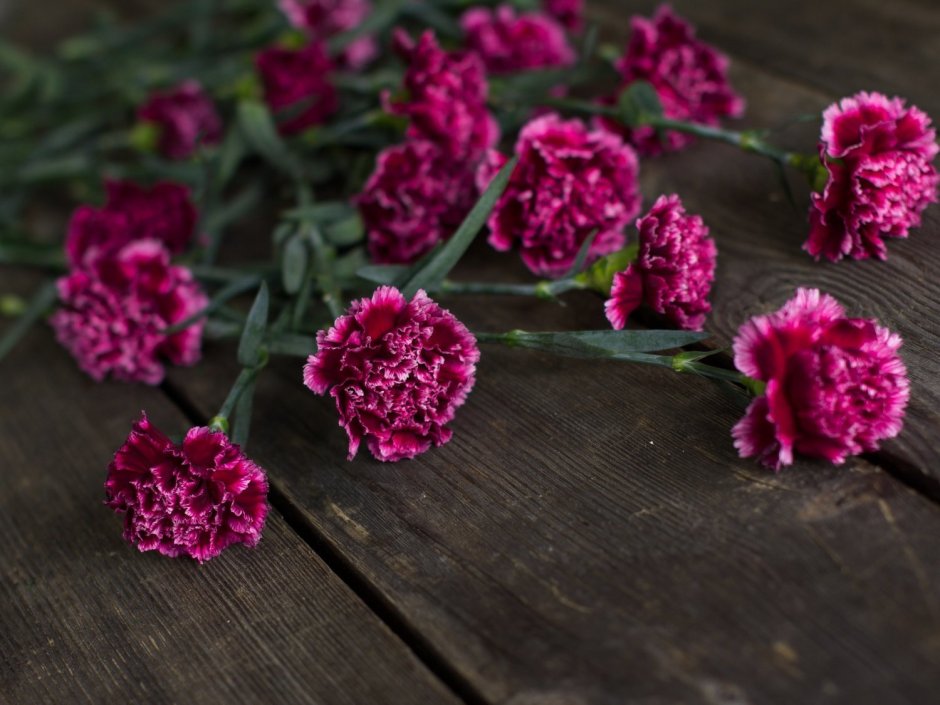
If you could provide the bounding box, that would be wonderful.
[0,0,940,705]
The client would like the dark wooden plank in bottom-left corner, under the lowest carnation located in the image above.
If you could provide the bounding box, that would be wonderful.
[0,270,457,705]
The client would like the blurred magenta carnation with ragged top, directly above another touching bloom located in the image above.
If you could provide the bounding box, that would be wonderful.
[385,31,499,162]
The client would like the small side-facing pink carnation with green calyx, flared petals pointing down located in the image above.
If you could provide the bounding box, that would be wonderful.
[604,195,718,330]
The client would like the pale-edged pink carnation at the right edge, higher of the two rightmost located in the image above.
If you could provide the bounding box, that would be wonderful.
[803,93,938,262]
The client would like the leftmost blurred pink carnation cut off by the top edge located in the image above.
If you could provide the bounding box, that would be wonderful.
[279,0,378,69]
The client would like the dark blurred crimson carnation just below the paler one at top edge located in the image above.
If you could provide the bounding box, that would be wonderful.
[255,42,339,136]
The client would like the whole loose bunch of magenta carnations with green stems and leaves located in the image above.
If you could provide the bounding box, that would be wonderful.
[0,0,938,561]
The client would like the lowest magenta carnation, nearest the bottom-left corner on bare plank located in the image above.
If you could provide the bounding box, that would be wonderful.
[104,415,268,563]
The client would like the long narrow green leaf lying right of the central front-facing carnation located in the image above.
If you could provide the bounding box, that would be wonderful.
[492,330,708,359]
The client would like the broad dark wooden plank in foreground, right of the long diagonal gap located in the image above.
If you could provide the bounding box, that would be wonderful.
[169,284,940,705]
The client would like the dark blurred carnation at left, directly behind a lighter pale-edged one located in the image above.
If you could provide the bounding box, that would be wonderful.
[65,181,198,267]
